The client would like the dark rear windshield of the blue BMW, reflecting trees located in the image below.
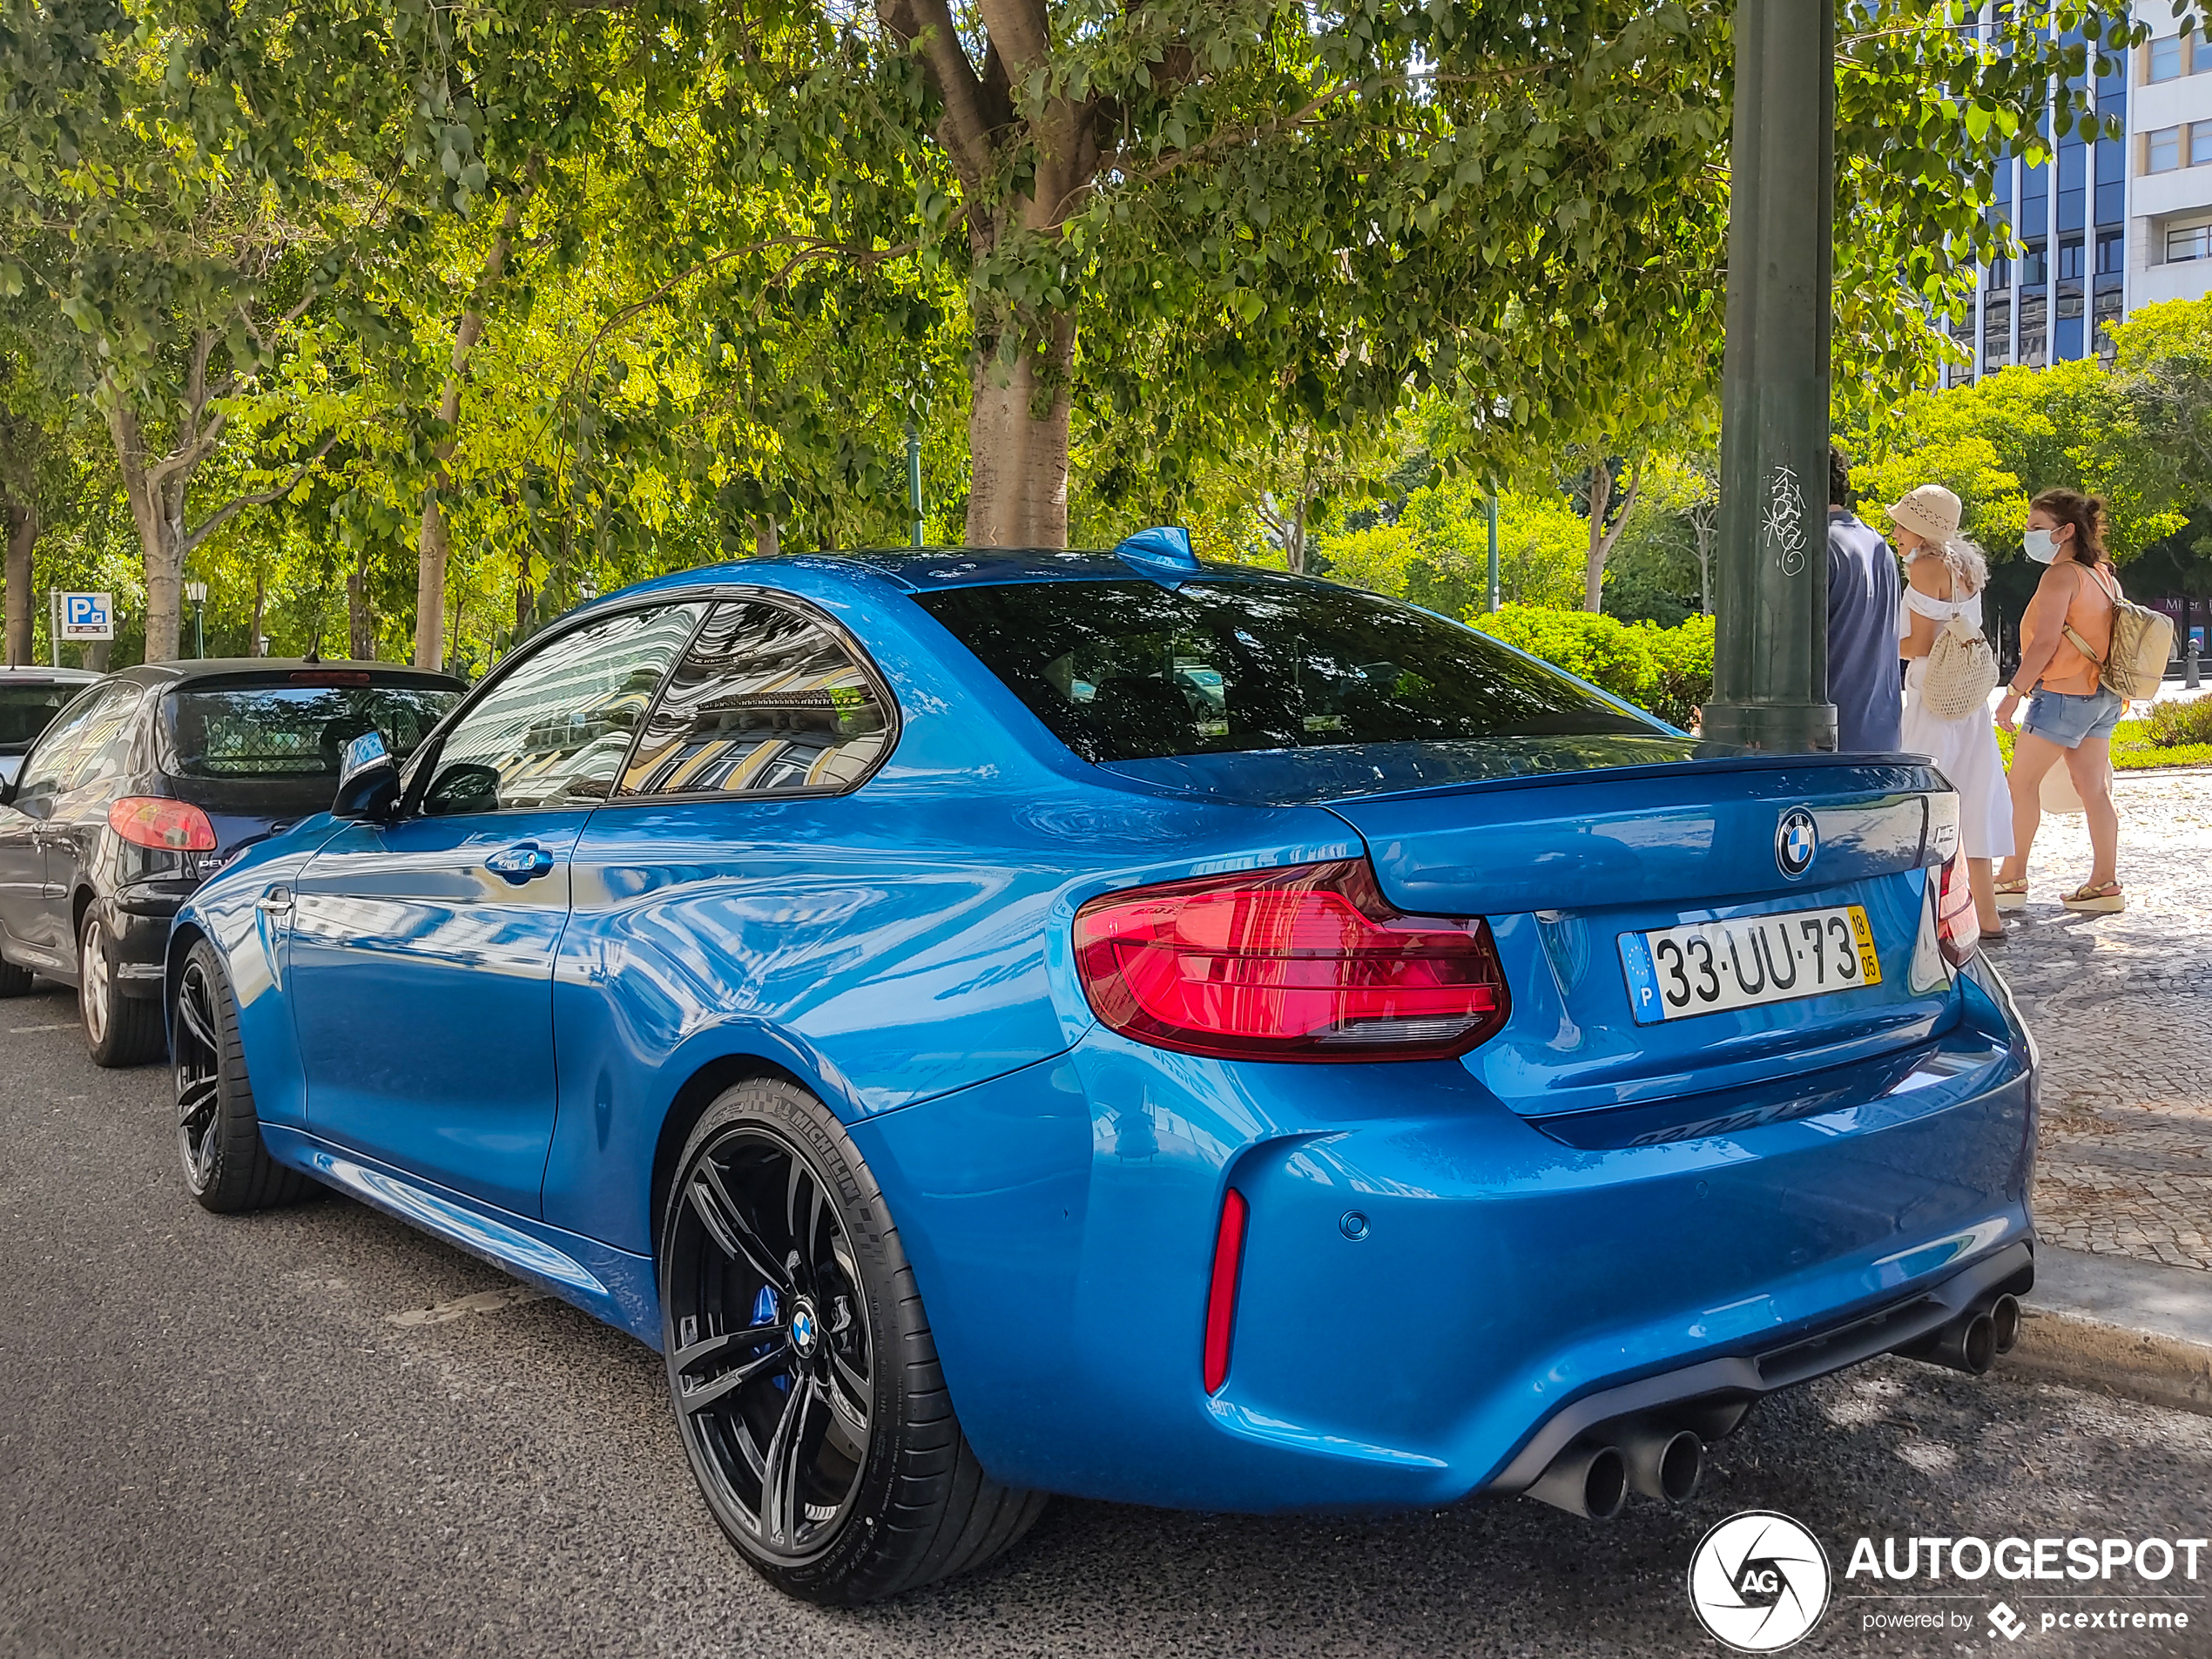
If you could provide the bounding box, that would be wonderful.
[916,582,1655,761]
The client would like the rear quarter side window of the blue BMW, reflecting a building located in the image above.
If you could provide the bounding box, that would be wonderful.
[622,599,892,796]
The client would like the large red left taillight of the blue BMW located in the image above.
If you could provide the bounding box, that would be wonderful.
[1075,860,1507,1060]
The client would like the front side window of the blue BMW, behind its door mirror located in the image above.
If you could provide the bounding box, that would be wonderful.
[422,602,705,814]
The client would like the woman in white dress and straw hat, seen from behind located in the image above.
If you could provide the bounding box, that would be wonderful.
[1889,484,2013,941]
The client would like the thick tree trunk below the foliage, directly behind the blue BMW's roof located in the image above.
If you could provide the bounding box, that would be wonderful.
[967,316,1075,546]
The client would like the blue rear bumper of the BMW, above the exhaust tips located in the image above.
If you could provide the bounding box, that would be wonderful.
[853,971,2035,1511]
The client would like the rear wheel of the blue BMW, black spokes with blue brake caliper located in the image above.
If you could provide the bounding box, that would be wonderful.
[661,1080,1044,1604]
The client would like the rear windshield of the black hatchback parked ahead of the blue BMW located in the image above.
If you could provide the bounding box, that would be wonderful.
[164,685,460,779]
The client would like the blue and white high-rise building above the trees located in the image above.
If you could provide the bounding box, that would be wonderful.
[1945,0,2212,385]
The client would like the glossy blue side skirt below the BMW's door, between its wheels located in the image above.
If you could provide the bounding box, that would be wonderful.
[261,1123,661,1352]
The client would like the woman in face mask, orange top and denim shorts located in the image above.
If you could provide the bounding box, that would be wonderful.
[1998,489,2128,911]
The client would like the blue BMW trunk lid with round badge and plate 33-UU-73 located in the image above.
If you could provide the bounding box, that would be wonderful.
[1330,757,1958,1117]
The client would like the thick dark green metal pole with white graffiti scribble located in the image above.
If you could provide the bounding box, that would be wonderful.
[1703,0,1836,754]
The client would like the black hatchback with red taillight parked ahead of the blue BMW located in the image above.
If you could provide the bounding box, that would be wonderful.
[0,657,462,1066]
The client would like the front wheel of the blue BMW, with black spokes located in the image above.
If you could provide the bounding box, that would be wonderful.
[171,941,316,1214]
